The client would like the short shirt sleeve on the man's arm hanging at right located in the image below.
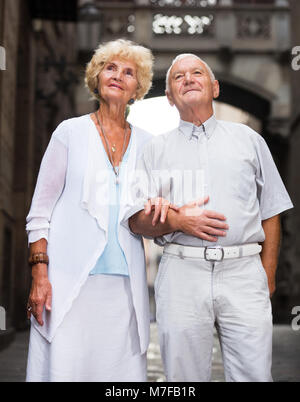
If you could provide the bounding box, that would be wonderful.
[256,136,293,220]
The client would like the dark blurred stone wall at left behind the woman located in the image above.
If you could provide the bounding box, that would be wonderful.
[0,0,77,347]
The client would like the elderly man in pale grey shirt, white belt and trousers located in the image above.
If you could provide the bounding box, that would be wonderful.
[130,54,292,381]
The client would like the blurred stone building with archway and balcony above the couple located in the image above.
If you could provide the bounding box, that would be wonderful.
[85,0,300,323]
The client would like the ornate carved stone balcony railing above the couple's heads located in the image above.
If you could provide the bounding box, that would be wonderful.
[78,0,290,52]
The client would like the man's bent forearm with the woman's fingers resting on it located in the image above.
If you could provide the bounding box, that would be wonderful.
[129,209,179,237]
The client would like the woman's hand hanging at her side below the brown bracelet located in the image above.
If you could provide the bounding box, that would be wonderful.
[27,264,52,326]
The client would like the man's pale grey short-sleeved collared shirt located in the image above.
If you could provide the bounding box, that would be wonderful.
[136,112,293,246]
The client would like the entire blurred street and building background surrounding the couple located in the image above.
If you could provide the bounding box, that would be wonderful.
[0,0,300,381]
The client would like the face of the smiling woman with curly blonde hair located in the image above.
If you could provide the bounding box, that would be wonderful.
[98,59,138,105]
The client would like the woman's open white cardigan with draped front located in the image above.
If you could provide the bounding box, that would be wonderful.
[26,115,152,353]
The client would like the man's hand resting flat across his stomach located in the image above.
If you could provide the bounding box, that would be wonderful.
[177,196,229,242]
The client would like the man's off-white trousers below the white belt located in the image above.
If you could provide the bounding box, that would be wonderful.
[155,253,272,382]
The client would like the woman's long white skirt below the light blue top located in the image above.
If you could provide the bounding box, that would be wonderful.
[26,275,147,382]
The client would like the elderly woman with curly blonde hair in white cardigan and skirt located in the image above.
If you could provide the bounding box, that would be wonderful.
[26,40,153,381]
